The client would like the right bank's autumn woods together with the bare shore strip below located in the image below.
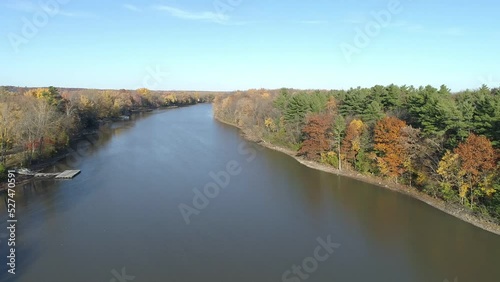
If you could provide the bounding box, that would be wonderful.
[214,85,500,235]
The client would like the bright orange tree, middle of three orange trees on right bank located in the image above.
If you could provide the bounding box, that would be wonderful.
[374,117,406,182]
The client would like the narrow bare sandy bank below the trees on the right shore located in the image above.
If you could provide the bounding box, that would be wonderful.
[214,117,500,235]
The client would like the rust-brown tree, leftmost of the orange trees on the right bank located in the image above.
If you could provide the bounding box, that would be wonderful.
[299,114,332,160]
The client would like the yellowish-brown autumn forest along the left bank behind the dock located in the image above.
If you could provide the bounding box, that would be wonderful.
[0,86,215,179]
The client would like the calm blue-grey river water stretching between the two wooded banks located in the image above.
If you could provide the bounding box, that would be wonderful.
[0,105,500,282]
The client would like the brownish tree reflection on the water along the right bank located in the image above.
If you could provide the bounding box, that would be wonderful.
[252,142,500,281]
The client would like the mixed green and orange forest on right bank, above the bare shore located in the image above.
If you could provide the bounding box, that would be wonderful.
[214,85,500,221]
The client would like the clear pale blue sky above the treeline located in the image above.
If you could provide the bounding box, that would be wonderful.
[0,0,500,91]
